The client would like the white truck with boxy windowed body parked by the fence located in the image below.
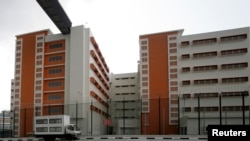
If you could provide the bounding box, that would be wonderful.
[34,115,81,141]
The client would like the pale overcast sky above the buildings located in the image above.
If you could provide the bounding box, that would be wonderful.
[0,0,250,112]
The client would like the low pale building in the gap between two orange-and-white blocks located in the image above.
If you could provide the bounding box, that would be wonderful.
[109,72,141,135]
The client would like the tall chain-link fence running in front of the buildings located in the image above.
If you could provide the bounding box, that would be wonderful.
[4,95,250,137]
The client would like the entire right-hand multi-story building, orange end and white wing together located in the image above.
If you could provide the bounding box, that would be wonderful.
[140,27,250,134]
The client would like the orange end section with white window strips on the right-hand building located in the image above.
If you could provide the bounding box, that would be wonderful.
[139,30,182,134]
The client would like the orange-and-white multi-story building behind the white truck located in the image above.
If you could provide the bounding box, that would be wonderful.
[11,26,109,136]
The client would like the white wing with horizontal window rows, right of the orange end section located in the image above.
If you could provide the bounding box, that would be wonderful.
[177,27,250,134]
